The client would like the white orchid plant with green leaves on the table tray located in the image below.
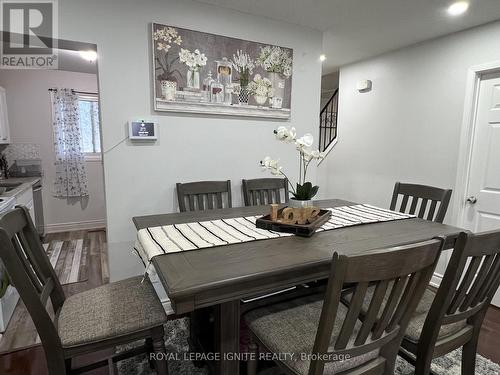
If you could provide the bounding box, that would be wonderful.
[260,126,325,200]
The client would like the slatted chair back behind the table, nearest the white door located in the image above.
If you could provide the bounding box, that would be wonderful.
[390,182,452,223]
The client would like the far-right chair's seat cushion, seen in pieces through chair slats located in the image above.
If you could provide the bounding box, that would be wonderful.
[344,284,467,343]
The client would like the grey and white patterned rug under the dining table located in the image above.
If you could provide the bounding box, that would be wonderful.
[118,318,500,375]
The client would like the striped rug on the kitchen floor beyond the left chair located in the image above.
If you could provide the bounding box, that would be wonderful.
[43,238,89,285]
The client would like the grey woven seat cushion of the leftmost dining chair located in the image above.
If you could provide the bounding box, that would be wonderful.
[58,276,167,347]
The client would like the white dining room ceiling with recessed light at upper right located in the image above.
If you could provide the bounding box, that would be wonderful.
[195,0,500,73]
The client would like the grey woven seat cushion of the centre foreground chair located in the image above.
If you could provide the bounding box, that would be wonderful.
[245,295,378,375]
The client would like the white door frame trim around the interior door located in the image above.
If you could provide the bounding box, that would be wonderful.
[453,61,500,227]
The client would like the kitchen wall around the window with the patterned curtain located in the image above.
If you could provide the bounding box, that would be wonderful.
[0,70,106,231]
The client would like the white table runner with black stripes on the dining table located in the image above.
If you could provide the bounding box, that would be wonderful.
[134,204,415,268]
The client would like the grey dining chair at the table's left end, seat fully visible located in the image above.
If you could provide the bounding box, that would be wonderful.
[0,207,168,375]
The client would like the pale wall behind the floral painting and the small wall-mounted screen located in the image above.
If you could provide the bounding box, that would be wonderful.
[59,0,322,279]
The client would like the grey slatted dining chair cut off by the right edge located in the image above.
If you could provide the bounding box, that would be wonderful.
[401,230,500,375]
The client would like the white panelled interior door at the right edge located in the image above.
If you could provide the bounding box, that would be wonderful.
[464,72,500,307]
